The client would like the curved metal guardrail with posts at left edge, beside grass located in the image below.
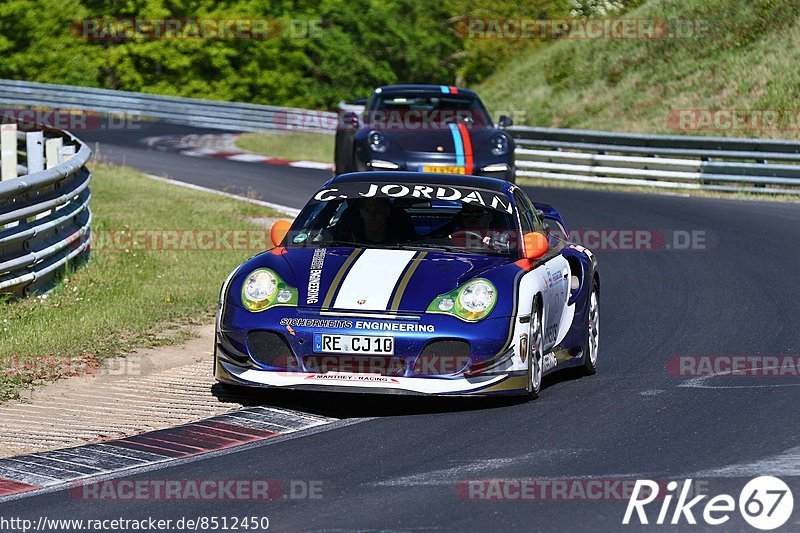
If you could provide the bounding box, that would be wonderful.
[0,124,92,297]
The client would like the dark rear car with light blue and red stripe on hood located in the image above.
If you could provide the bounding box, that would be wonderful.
[334,85,515,183]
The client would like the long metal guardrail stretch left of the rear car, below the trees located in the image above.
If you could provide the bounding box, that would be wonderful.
[0,79,338,133]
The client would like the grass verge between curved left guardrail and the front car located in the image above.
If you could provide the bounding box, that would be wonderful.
[0,165,277,402]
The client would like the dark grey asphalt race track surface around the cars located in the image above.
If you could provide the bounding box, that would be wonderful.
[0,127,800,531]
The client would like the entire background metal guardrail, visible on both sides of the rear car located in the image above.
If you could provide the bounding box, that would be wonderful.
[0,80,800,194]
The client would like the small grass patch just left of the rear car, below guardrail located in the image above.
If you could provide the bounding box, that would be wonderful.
[236,132,335,163]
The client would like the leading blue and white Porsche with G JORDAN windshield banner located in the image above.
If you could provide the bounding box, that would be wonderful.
[214,172,600,397]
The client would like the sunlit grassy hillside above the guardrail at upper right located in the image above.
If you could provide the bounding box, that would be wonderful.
[476,0,800,139]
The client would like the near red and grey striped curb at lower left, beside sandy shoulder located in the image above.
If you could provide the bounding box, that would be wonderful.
[0,407,337,502]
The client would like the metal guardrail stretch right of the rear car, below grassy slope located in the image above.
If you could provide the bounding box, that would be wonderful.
[509,127,800,194]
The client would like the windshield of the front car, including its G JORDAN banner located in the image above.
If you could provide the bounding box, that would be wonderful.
[286,183,519,256]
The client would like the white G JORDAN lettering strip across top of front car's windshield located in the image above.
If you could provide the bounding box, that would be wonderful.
[314,182,514,214]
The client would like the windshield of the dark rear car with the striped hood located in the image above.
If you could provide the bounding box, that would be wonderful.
[365,93,492,128]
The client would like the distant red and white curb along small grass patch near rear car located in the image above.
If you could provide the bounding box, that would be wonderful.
[144,133,333,170]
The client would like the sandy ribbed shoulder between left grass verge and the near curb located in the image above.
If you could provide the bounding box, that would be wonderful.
[0,324,247,457]
